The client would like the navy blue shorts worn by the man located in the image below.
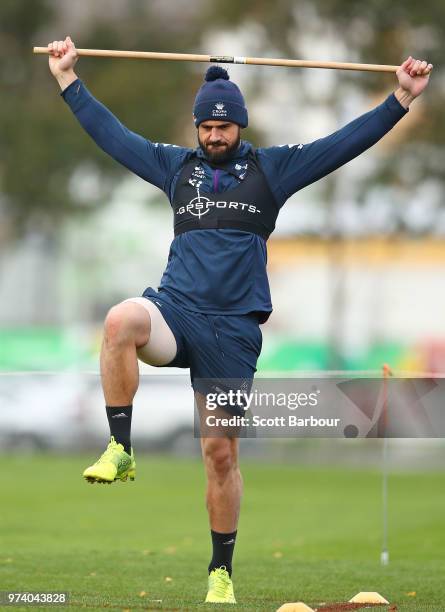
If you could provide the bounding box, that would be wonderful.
[143,287,262,412]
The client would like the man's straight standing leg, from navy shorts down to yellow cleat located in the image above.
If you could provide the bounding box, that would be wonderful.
[183,313,262,603]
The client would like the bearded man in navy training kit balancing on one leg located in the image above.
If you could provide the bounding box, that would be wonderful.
[48,37,432,603]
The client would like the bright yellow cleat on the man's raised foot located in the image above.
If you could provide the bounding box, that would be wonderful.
[82,436,136,484]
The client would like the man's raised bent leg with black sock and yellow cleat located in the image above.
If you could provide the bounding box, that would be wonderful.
[83,298,177,483]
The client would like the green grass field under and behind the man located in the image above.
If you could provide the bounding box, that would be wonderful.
[0,456,445,612]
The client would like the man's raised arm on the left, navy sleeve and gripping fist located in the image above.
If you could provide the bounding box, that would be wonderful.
[49,37,188,192]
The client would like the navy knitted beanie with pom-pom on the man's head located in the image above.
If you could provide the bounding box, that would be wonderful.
[193,66,248,127]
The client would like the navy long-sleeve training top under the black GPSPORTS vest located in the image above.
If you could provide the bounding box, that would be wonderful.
[62,79,408,322]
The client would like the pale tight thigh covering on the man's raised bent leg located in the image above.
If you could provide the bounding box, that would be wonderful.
[123,297,178,366]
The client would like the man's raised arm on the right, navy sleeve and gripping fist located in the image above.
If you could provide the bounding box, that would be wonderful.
[262,57,432,203]
